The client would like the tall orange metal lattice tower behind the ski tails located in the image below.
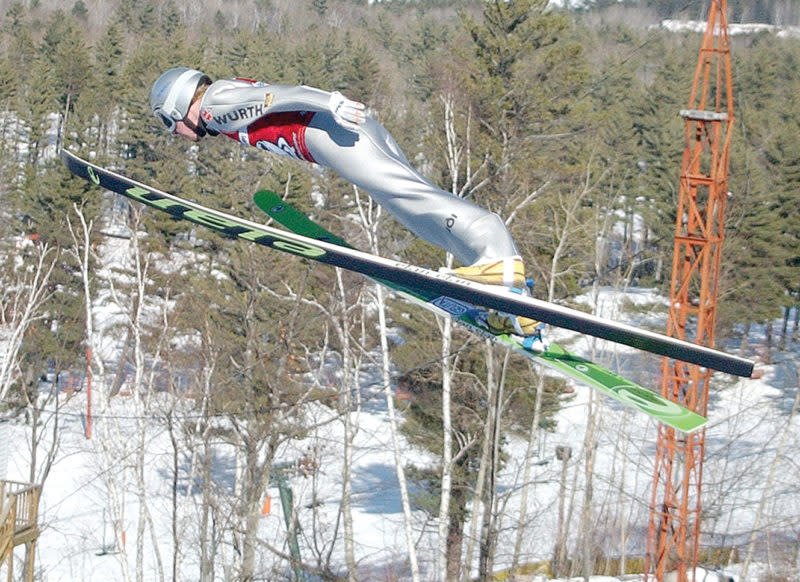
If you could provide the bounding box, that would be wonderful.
[646,0,733,582]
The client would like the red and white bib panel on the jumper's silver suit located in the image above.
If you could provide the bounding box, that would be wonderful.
[222,111,314,162]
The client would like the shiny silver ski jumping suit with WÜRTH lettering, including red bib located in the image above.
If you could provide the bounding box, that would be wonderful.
[200,79,519,265]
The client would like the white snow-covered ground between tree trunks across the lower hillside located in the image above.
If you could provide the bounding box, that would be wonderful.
[0,289,800,582]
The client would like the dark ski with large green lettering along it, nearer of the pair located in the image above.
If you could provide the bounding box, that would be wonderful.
[61,150,753,384]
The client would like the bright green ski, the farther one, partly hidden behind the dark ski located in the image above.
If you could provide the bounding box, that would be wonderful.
[253,190,707,432]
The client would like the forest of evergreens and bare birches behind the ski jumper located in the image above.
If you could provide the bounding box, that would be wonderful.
[0,0,800,580]
